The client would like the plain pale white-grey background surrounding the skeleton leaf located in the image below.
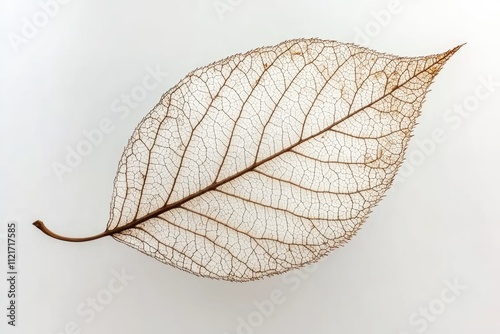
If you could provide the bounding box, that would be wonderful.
[0,0,500,334]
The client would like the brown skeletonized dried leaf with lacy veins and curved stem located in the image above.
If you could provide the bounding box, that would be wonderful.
[35,39,460,281]
